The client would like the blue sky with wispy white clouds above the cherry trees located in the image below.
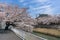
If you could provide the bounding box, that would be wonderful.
[0,0,60,18]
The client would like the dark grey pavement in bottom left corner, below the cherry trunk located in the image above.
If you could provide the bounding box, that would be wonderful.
[0,31,20,40]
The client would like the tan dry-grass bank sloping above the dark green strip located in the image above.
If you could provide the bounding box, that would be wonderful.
[34,28,60,37]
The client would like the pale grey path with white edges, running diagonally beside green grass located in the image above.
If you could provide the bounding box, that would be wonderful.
[11,28,47,40]
